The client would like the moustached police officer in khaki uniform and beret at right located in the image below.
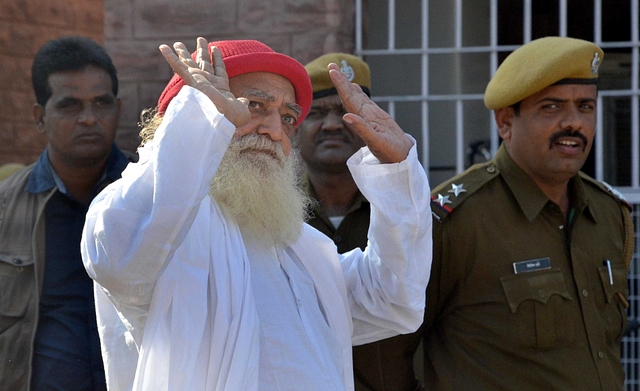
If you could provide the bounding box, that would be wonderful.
[418,37,633,391]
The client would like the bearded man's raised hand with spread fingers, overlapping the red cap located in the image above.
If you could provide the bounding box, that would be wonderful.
[160,37,251,127]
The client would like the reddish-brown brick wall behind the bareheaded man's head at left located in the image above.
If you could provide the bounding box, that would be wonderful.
[0,0,104,165]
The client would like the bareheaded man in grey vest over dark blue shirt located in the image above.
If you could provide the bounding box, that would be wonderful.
[0,37,135,391]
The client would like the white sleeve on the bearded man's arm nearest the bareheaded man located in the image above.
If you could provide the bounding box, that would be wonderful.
[81,86,235,330]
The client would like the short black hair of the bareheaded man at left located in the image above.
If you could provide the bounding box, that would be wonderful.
[31,36,118,106]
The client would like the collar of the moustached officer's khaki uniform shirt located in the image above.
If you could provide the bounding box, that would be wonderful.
[494,144,596,222]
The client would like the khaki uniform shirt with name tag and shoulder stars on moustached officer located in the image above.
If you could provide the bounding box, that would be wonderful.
[419,147,633,391]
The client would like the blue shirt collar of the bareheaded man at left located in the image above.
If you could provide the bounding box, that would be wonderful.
[26,143,129,195]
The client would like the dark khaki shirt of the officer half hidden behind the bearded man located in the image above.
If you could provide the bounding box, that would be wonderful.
[303,175,421,391]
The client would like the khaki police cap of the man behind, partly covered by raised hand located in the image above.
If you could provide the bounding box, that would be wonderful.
[304,53,371,99]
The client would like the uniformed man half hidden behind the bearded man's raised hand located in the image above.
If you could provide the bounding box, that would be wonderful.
[296,53,421,391]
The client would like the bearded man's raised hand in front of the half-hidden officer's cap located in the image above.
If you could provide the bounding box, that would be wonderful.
[328,63,413,163]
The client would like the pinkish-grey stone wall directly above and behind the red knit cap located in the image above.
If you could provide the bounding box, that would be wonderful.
[104,0,354,151]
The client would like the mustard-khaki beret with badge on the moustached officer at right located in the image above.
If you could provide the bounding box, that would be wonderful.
[484,37,604,110]
